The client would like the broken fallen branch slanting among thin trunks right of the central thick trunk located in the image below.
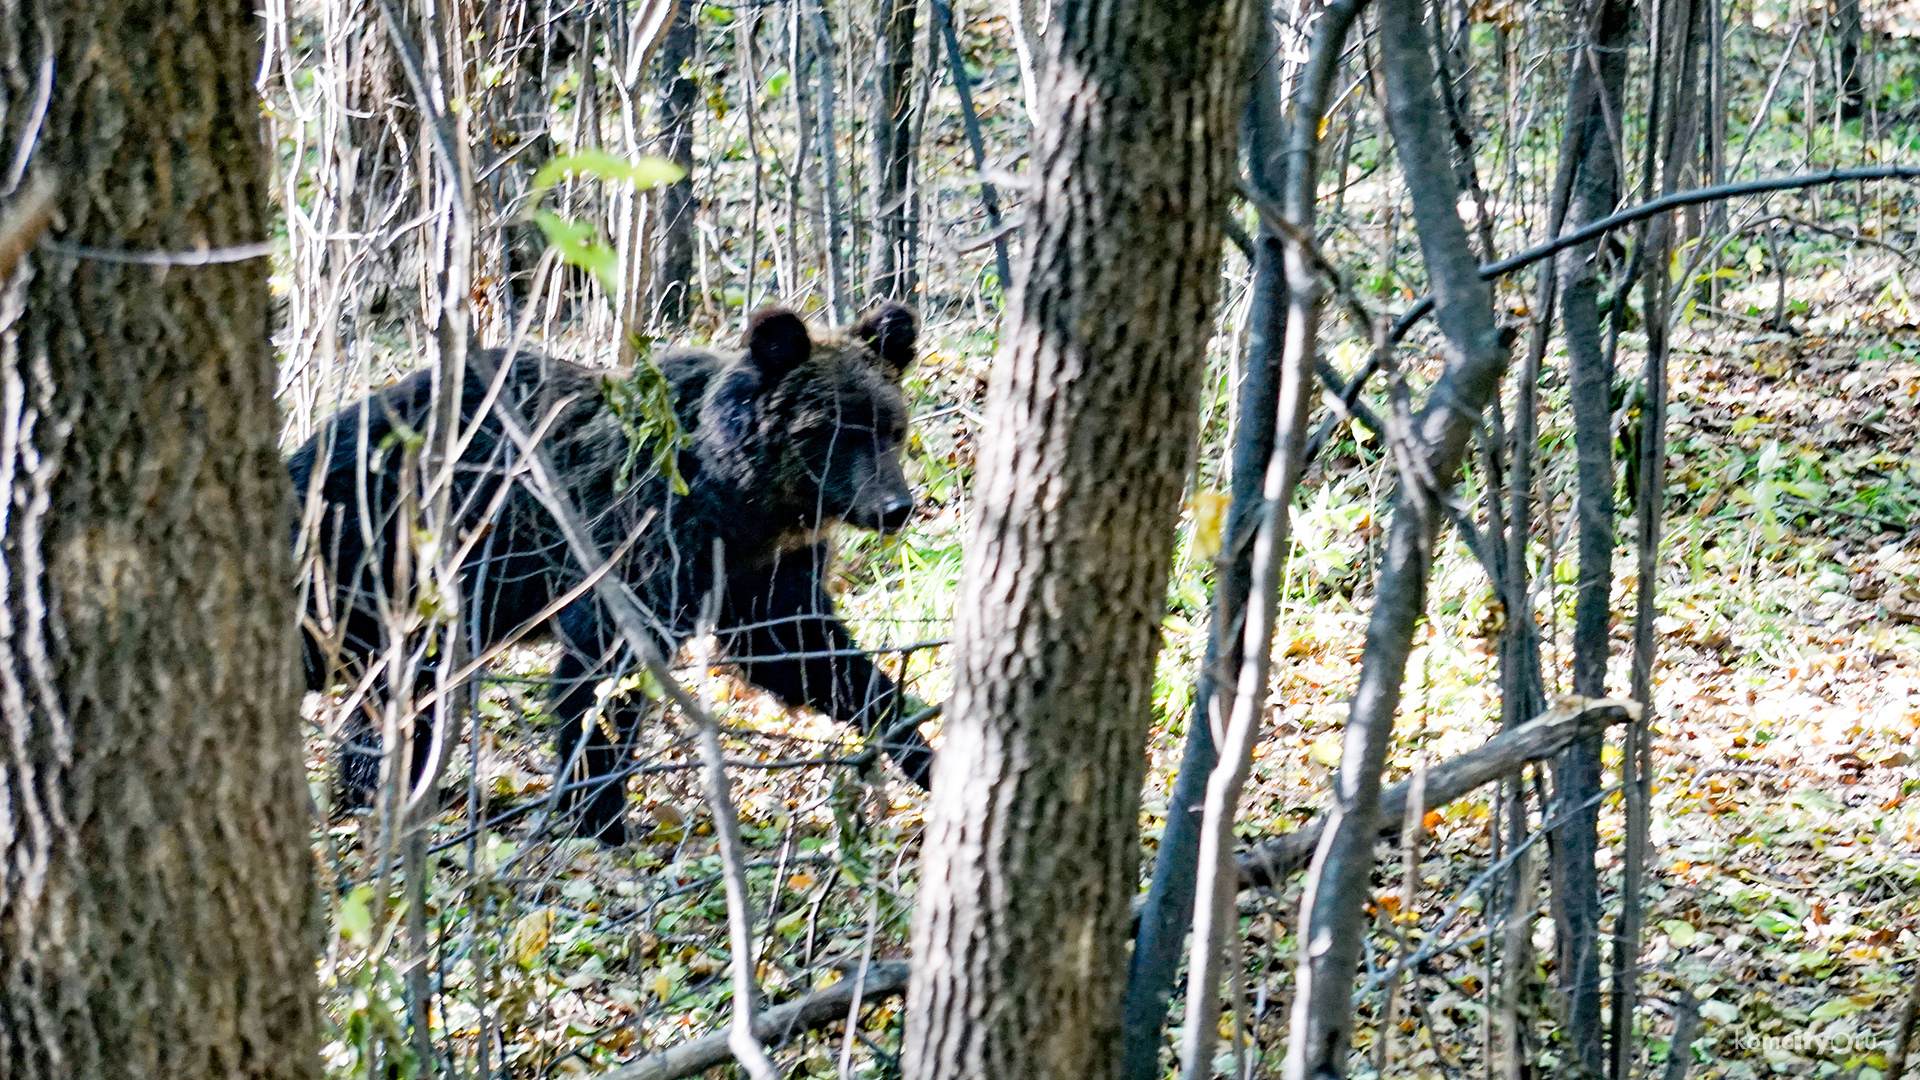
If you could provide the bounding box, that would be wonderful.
[1238,694,1640,888]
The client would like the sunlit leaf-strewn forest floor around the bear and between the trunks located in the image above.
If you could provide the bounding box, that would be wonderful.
[315,256,1920,1080]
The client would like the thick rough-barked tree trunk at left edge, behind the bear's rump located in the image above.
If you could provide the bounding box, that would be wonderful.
[0,0,319,1080]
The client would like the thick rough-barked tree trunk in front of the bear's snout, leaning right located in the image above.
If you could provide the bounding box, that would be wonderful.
[904,0,1252,1080]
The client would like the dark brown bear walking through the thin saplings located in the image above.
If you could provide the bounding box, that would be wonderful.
[288,306,931,844]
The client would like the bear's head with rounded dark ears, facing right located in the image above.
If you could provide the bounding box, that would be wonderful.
[697,304,920,532]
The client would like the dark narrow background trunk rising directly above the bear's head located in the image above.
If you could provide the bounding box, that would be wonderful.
[866,0,918,302]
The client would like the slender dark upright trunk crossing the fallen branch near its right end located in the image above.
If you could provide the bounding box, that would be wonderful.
[1553,0,1632,1076]
